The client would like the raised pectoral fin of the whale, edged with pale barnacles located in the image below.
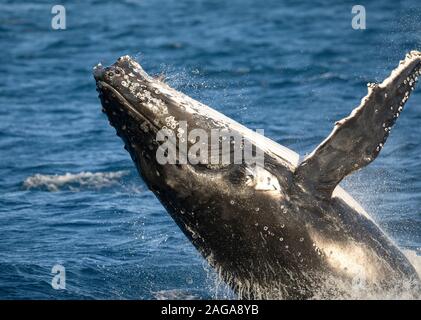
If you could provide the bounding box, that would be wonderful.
[295,51,421,199]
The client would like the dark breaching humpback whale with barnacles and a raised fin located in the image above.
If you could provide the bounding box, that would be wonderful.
[93,51,421,299]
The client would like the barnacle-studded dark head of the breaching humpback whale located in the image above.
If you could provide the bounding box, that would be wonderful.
[93,56,298,262]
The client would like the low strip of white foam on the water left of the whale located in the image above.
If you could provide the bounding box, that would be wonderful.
[23,170,129,192]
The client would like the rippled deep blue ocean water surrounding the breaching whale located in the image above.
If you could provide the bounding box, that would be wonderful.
[0,0,421,299]
